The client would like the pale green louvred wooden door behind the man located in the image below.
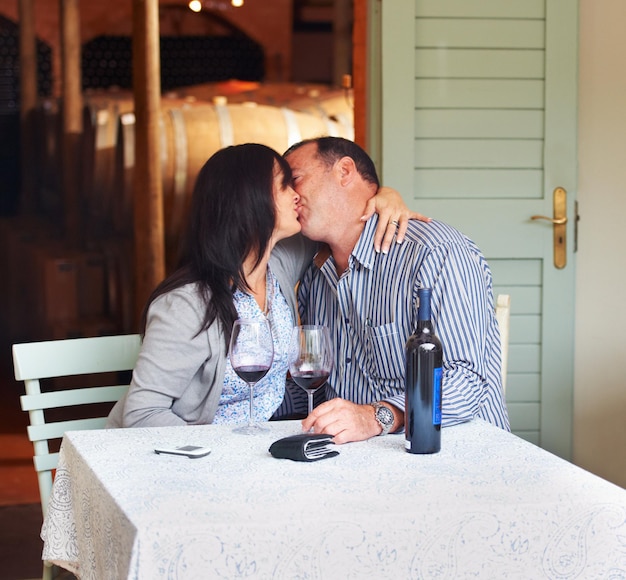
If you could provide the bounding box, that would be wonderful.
[370,0,578,458]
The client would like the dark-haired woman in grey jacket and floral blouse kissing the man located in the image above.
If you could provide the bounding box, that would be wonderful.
[107,143,420,427]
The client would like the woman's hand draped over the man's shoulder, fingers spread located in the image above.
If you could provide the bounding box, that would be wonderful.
[361,187,431,254]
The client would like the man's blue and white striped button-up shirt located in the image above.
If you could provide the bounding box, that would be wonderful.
[298,216,510,430]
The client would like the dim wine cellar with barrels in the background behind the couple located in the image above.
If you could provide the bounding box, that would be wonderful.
[0,0,354,347]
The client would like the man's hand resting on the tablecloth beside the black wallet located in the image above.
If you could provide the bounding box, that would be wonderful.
[302,399,381,443]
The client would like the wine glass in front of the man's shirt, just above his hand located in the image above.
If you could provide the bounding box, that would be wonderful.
[289,325,333,415]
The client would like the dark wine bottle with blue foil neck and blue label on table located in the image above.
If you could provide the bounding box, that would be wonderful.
[404,288,443,453]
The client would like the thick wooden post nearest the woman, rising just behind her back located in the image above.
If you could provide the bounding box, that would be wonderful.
[133,0,165,324]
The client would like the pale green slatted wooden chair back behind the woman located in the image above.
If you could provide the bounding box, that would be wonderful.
[13,334,141,516]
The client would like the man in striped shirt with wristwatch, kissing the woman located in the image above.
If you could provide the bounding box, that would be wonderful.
[285,137,509,443]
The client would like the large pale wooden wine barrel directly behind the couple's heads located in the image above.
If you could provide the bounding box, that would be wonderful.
[114,103,352,269]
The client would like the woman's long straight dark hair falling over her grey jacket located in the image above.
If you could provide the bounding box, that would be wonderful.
[141,143,292,345]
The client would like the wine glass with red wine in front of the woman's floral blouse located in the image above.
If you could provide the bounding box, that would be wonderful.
[229,318,274,435]
